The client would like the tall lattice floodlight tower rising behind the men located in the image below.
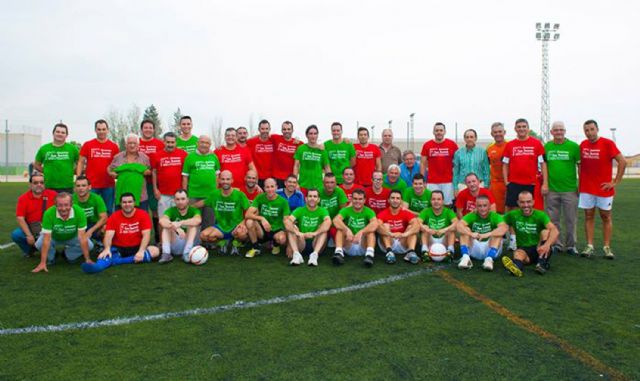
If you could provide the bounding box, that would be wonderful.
[536,22,560,141]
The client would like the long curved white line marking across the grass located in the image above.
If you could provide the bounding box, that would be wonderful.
[0,265,448,336]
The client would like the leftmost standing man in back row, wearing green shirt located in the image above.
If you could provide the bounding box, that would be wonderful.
[33,123,80,193]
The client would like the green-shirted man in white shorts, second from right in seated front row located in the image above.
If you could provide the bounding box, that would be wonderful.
[458,195,509,271]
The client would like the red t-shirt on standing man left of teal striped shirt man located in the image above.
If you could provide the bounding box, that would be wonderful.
[420,139,458,184]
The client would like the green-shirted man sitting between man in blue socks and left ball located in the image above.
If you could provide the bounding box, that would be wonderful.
[158,189,202,263]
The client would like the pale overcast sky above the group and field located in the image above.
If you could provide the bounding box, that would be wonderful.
[0,0,640,154]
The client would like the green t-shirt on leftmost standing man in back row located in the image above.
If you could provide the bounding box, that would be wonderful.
[36,143,80,189]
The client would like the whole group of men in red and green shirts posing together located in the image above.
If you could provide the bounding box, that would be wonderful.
[12,116,625,276]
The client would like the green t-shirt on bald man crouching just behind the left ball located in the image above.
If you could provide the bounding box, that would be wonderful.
[205,188,249,232]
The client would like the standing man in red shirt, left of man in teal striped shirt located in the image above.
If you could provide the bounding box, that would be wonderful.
[420,122,458,206]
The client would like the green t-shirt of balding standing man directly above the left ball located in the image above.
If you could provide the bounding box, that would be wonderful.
[182,152,220,198]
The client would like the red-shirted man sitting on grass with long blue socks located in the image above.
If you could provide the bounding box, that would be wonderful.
[81,192,160,273]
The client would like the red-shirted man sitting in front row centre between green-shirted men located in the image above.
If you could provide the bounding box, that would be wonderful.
[377,190,420,265]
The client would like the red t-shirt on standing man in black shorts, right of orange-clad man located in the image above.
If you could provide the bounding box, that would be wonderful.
[502,136,544,185]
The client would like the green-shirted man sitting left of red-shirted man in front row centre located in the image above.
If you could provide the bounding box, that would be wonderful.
[333,189,378,267]
